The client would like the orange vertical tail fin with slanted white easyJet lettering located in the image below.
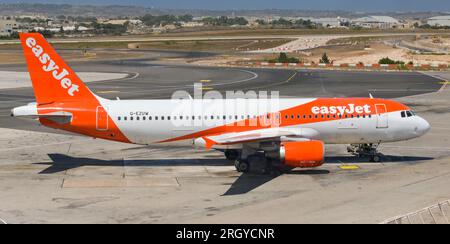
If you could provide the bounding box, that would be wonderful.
[20,33,95,104]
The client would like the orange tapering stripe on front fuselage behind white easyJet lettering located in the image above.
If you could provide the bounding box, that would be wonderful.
[159,98,410,143]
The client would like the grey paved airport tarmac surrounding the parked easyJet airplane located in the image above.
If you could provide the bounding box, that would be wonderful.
[0,50,450,223]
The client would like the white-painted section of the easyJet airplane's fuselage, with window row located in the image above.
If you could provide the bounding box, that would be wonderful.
[97,99,429,147]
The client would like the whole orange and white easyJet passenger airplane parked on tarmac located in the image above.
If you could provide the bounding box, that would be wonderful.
[11,33,431,173]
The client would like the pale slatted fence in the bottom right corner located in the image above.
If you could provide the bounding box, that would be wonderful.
[382,200,450,224]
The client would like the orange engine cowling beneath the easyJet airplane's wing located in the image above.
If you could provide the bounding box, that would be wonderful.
[280,141,325,168]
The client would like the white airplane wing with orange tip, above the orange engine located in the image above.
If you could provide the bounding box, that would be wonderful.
[195,127,319,149]
